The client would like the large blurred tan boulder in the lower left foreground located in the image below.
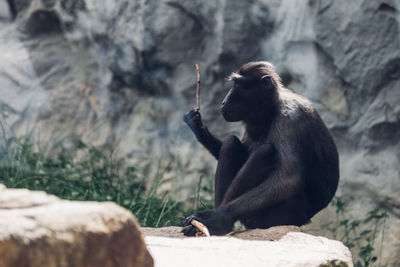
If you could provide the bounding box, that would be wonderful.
[0,185,153,267]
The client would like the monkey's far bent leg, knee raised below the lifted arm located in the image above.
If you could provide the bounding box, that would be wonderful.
[215,135,247,208]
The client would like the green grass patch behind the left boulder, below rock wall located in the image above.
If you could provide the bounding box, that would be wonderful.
[0,126,194,227]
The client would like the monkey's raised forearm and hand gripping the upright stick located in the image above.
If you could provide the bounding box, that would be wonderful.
[183,109,222,159]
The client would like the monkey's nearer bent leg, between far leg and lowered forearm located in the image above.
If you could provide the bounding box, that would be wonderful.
[222,144,277,205]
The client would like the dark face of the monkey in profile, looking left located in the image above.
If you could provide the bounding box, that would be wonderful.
[221,78,267,122]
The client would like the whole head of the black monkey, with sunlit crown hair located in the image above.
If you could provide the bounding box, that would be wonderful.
[221,62,282,122]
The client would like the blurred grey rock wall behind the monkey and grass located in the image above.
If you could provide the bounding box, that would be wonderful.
[0,0,400,264]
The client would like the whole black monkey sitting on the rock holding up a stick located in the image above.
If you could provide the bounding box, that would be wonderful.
[181,62,339,235]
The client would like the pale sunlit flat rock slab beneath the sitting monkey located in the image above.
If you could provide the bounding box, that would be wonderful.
[145,230,353,267]
